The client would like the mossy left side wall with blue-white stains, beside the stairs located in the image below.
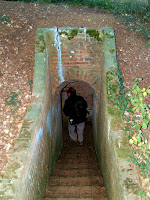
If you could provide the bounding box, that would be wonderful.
[0,28,63,200]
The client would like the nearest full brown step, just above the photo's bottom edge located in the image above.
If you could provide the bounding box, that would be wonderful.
[45,186,107,199]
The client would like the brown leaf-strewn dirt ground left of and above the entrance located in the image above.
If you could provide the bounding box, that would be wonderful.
[0,1,150,184]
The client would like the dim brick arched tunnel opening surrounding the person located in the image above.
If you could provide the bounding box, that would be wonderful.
[54,79,99,156]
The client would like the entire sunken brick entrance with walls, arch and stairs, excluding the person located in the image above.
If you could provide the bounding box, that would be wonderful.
[1,27,142,200]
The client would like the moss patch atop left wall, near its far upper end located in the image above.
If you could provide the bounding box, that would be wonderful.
[35,35,46,53]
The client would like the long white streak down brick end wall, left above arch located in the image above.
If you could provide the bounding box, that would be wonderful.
[54,27,64,83]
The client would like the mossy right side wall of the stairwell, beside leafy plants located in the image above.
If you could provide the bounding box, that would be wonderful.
[93,29,142,200]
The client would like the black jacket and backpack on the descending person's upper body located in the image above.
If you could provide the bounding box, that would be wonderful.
[63,96,87,124]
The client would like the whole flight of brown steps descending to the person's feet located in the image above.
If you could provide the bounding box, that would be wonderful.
[43,124,108,200]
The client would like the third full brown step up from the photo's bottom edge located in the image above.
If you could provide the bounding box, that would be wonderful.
[53,168,101,177]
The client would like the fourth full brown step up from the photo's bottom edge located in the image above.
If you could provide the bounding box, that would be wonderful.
[55,161,99,170]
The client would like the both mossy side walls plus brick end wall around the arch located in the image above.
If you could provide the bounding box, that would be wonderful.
[0,27,143,200]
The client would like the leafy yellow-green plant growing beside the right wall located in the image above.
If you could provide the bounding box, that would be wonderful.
[129,78,150,178]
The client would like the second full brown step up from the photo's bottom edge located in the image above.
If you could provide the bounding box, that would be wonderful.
[49,176,104,187]
